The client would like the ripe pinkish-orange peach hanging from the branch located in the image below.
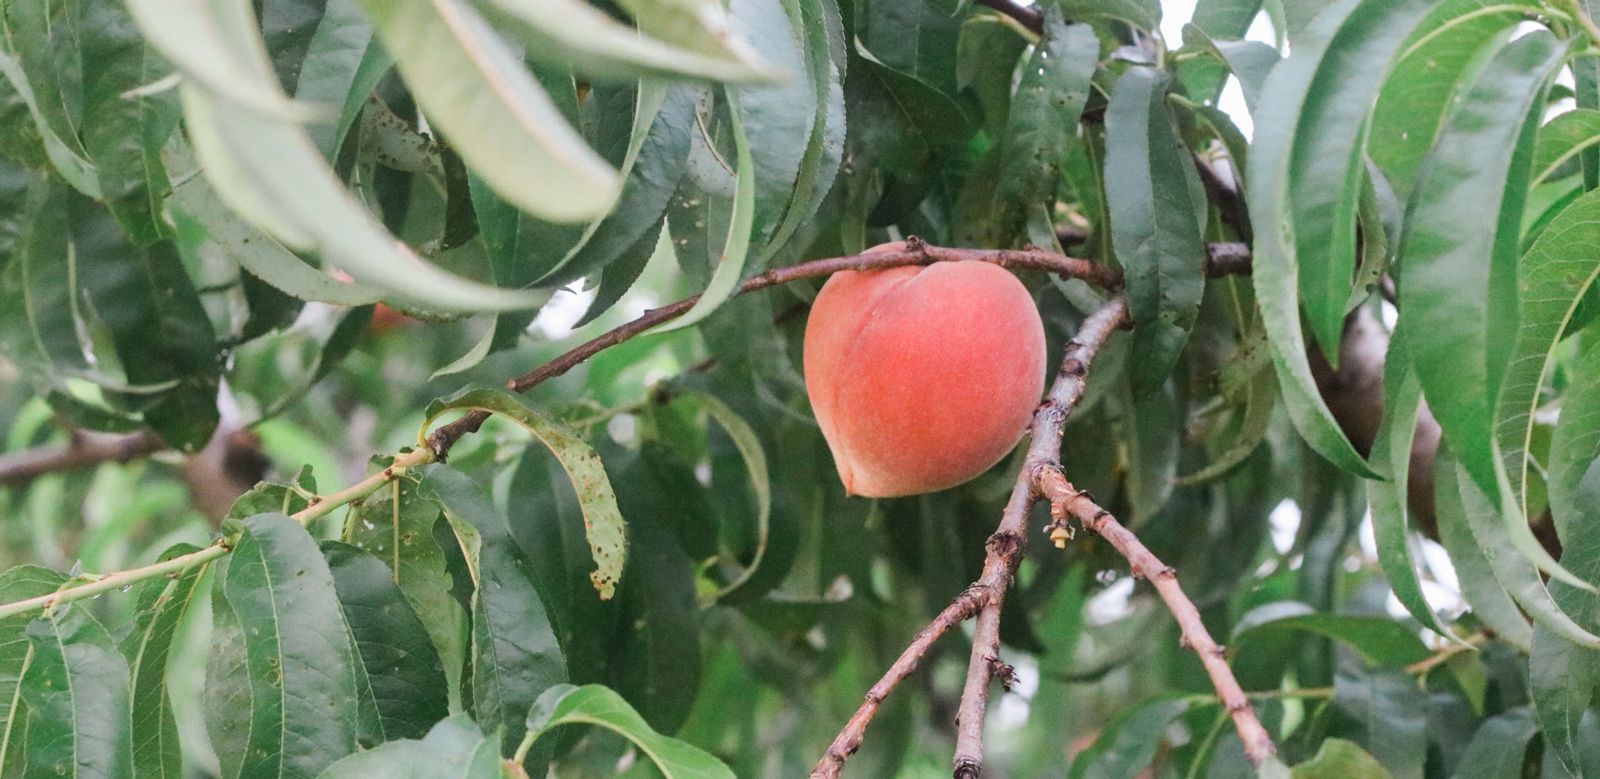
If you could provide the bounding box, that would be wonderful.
[805,243,1045,497]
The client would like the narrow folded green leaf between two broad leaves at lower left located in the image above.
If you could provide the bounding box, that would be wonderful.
[122,544,210,777]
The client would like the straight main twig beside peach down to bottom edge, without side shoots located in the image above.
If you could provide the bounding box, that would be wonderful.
[952,296,1128,779]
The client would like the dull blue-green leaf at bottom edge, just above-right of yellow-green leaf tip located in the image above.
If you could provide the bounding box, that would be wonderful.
[1333,669,1427,779]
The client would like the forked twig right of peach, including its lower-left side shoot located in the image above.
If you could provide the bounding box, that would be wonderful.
[811,298,1128,779]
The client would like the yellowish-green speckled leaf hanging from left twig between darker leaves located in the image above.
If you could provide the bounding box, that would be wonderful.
[342,473,467,713]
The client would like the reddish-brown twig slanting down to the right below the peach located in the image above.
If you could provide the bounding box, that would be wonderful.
[1038,467,1277,768]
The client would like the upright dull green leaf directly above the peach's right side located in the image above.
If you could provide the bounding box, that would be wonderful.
[995,8,1100,216]
